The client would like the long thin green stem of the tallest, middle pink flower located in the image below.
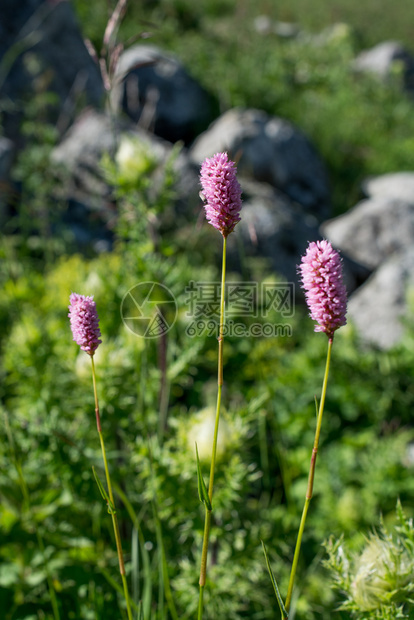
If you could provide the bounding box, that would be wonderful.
[198,235,226,620]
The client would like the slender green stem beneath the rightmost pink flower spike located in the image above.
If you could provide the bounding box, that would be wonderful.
[285,336,333,611]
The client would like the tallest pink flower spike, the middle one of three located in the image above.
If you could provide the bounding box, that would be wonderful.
[200,153,242,237]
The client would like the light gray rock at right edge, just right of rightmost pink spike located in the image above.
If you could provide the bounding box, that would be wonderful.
[348,247,414,349]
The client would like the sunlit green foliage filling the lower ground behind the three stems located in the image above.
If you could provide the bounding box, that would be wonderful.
[0,156,414,620]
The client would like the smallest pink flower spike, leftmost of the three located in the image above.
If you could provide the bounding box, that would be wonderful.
[68,293,102,356]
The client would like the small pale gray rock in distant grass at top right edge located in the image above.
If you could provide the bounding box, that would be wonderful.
[354,41,414,90]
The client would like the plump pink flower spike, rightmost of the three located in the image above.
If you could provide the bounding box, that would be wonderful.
[299,239,347,339]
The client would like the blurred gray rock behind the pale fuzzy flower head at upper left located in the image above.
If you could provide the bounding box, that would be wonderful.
[52,110,200,239]
